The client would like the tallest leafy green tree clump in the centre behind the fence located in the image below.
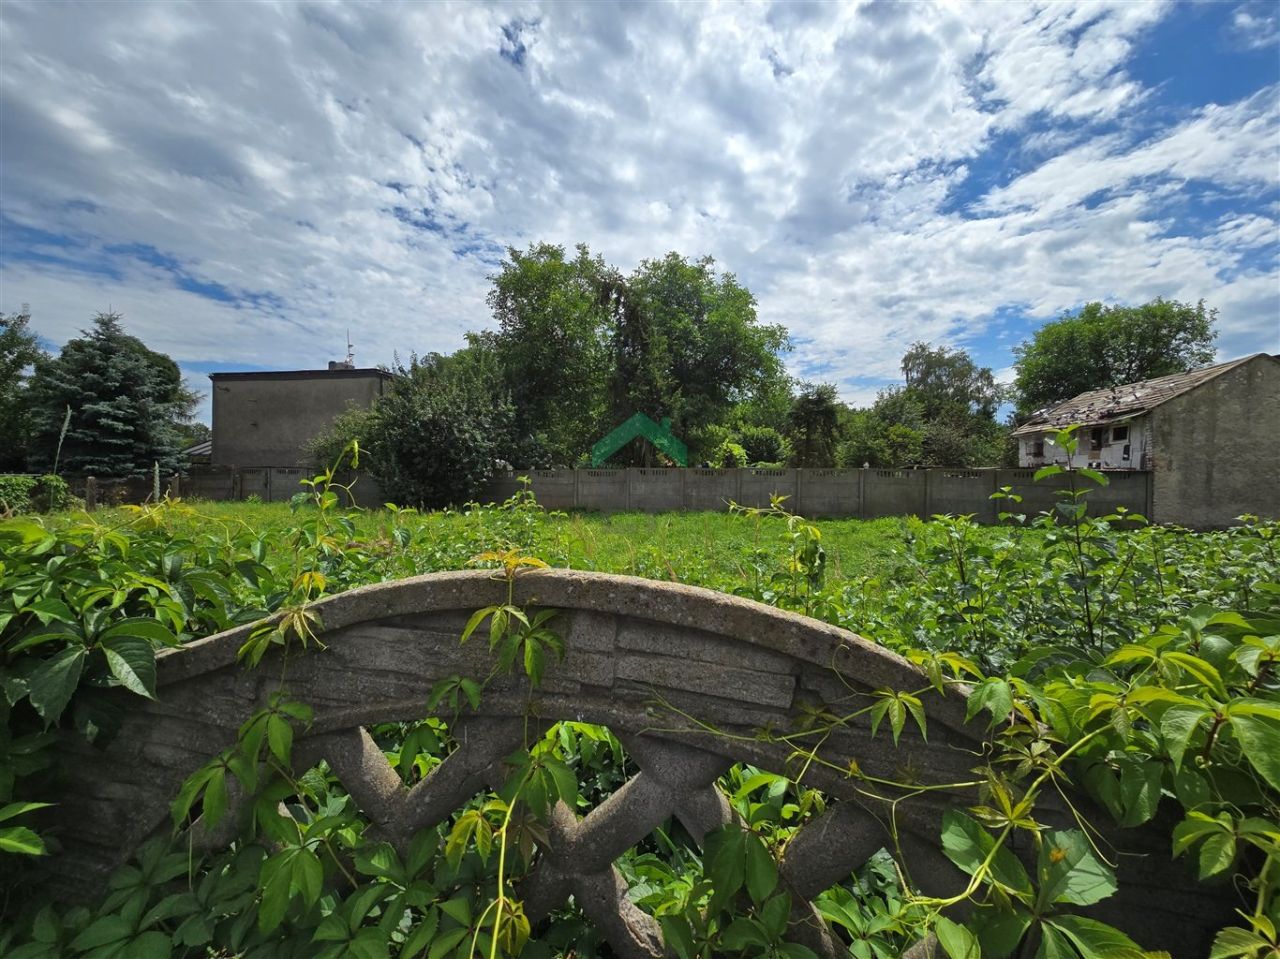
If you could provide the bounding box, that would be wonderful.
[483,243,788,467]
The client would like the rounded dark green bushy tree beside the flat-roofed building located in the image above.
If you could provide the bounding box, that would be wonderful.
[360,356,516,510]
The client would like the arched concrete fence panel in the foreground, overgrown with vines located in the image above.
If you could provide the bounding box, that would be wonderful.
[52,570,1216,956]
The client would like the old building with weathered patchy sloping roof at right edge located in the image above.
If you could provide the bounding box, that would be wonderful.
[1014,353,1280,526]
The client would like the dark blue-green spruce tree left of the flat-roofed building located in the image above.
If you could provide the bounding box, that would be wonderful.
[28,312,197,479]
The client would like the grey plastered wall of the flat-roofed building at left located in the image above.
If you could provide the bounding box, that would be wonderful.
[210,370,392,467]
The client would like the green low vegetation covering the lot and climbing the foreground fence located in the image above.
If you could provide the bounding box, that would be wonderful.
[0,448,1280,959]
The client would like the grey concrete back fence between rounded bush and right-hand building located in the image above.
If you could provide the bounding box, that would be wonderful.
[480,469,1176,522]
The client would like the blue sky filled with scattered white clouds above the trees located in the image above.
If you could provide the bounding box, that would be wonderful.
[0,0,1280,419]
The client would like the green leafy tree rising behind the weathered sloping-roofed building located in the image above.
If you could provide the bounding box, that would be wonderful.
[1014,298,1217,416]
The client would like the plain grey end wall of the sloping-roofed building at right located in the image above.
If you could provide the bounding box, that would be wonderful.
[1151,356,1280,528]
